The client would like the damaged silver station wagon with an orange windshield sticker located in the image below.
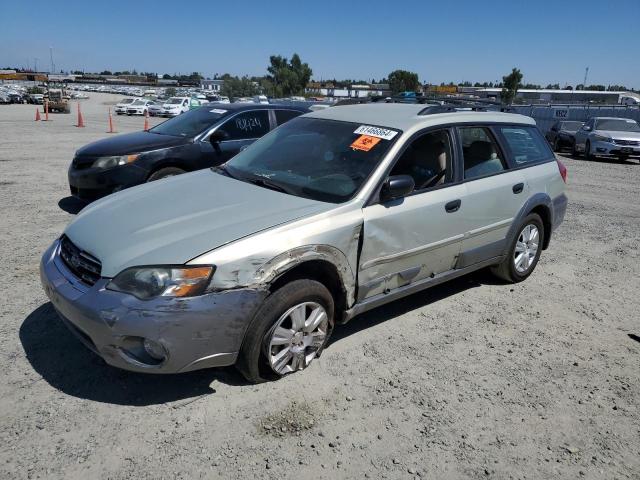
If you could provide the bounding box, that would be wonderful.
[40,104,567,382]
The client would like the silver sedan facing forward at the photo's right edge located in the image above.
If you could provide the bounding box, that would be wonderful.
[573,117,640,160]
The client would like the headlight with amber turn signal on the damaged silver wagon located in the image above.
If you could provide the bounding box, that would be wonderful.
[107,266,214,300]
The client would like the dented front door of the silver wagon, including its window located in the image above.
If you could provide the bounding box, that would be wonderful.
[358,130,465,301]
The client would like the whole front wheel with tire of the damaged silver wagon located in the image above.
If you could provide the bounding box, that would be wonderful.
[236,279,334,383]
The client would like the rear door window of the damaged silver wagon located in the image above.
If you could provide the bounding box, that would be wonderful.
[459,127,505,180]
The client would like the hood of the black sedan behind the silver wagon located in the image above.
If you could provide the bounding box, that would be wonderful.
[76,131,191,157]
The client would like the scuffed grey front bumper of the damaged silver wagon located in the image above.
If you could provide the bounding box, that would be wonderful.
[40,240,266,373]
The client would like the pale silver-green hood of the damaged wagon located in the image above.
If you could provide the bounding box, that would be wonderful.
[65,170,334,277]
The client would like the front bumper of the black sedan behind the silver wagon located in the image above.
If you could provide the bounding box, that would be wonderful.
[68,163,149,201]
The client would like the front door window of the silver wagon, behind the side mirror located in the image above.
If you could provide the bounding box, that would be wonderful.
[390,130,453,190]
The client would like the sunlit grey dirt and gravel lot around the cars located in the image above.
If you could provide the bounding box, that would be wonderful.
[0,94,640,479]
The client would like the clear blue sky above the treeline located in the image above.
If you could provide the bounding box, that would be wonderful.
[0,0,640,88]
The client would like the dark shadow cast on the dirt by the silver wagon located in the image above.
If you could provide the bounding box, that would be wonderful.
[20,271,492,406]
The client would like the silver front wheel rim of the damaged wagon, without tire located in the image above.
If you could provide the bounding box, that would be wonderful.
[265,302,329,375]
